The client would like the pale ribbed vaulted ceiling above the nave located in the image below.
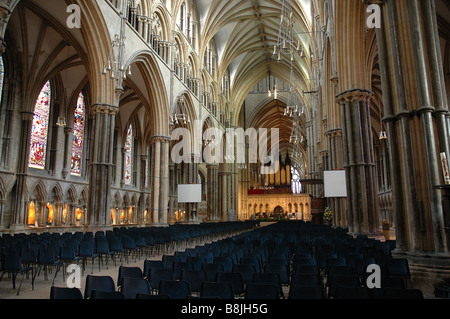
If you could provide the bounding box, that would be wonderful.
[196,0,313,112]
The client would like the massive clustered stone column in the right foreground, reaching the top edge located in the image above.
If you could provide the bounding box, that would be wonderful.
[376,0,449,253]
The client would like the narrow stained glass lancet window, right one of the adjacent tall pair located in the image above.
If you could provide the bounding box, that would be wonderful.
[71,92,86,176]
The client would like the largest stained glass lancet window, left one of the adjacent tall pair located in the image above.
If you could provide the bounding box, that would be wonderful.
[29,81,51,169]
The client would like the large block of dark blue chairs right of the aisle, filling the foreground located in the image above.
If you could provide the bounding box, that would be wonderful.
[49,222,423,299]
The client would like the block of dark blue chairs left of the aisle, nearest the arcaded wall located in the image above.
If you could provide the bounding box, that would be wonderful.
[0,222,258,294]
